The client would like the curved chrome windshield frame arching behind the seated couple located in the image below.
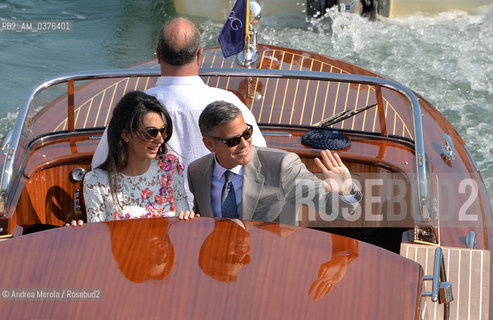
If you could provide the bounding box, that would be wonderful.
[0,68,432,222]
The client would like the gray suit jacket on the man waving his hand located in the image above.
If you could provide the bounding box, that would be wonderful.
[188,146,352,225]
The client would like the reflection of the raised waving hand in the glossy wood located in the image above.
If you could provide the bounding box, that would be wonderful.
[308,235,358,300]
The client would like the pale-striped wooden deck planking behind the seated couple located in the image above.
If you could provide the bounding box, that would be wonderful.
[33,46,414,138]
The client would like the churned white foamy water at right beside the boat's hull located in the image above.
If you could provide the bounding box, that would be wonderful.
[254,6,493,198]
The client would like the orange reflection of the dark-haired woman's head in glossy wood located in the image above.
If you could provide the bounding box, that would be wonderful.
[109,219,175,282]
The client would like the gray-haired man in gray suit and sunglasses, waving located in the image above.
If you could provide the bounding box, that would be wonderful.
[188,101,361,225]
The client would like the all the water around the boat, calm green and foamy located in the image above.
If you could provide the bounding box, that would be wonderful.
[0,0,493,198]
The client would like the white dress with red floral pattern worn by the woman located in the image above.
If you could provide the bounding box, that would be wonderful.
[84,153,189,222]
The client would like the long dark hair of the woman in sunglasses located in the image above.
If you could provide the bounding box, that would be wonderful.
[101,91,173,203]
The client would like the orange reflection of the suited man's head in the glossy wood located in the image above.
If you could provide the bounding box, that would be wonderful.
[199,219,296,282]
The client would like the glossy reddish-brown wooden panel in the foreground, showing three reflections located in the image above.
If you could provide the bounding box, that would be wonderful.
[0,218,423,320]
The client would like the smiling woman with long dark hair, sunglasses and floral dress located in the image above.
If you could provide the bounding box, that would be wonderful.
[84,91,194,222]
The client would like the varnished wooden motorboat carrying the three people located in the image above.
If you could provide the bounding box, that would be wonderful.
[0,8,493,319]
